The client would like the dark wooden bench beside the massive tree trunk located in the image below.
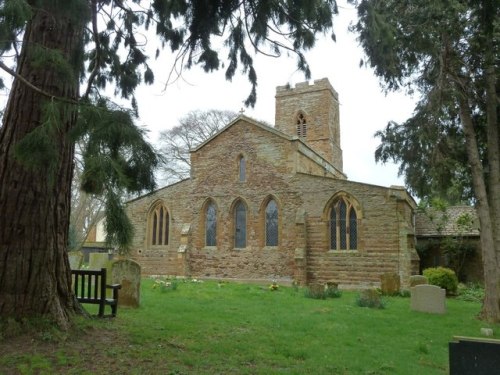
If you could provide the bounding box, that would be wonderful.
[71,268,121,317]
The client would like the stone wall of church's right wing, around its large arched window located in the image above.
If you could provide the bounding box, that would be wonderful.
[286,175,418,287]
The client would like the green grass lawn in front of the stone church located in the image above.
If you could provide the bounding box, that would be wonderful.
[0,280,500,374]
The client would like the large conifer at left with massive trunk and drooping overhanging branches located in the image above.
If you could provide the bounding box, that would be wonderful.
[0,0,337,327]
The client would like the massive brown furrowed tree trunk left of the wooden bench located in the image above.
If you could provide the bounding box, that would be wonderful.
[0,1,83,328]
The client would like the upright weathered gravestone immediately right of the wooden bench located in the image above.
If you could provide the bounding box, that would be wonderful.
[111,259,141,307]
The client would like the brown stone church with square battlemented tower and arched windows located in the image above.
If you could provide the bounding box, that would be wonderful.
[127,79,418,288]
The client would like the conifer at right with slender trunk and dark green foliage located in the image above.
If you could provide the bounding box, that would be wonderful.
[354,0,500,322]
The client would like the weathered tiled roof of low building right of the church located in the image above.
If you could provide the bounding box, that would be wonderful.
[415,206,479,237]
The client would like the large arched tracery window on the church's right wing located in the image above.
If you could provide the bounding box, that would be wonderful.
[330,197,358,250]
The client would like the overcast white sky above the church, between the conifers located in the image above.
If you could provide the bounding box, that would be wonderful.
[137,5,416,191]
